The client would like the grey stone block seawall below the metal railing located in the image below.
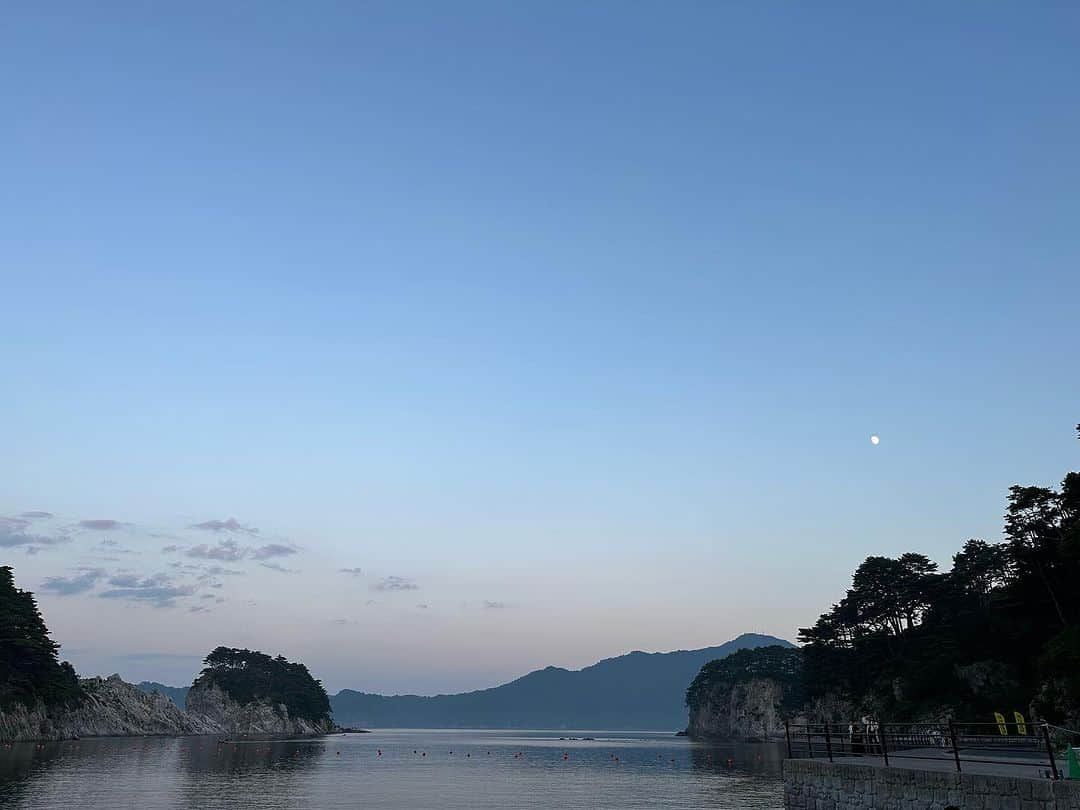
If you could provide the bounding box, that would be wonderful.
[784,759,1080,810]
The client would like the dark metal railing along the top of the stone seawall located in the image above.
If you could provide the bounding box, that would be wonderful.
[784,720,1062,779]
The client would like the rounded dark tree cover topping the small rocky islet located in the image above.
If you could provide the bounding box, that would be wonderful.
[194,647,330,723]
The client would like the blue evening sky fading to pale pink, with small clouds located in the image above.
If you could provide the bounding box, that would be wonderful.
[0,0,1080,693]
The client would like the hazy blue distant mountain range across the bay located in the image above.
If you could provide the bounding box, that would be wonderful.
[138,633,794,731]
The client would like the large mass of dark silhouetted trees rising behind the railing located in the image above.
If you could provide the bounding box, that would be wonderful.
[799,426,1080,721]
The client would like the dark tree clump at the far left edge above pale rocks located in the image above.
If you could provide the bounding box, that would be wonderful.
[0,566,80,708]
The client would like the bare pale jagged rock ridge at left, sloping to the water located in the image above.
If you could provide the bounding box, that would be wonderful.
[0,675,225,742]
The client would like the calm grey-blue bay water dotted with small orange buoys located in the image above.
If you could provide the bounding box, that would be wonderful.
[0,730,783,810]
